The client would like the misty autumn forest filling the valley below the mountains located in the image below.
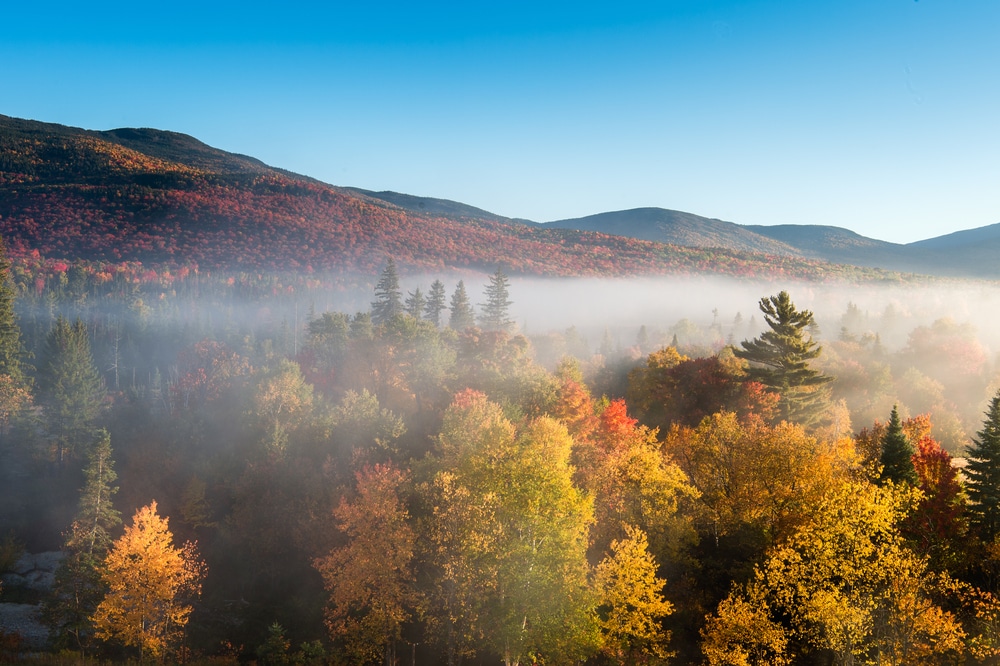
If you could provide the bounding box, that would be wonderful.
[0,246,1000,666]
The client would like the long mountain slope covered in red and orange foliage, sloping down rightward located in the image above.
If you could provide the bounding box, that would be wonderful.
[0,116,898,280]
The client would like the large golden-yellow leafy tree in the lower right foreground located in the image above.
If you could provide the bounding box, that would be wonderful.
[705,482,964,666]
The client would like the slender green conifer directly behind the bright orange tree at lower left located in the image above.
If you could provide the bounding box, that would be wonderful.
[44,430,121,652]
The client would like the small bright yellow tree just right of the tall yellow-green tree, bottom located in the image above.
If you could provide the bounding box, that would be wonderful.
[595,525,674,664]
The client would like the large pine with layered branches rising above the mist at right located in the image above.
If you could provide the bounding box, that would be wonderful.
[734,291,832,427]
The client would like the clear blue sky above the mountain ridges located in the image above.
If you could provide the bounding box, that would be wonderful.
[0,0,1000,242]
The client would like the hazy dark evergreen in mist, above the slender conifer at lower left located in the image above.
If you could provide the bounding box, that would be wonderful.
[39,316,105,463]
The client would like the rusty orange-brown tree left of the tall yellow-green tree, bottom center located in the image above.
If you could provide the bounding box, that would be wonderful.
[314,465,417,666]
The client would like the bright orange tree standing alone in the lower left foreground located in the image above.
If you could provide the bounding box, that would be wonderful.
[92,502,205,661]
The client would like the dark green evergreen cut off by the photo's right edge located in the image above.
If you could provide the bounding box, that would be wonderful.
[965,391,1000,542]
